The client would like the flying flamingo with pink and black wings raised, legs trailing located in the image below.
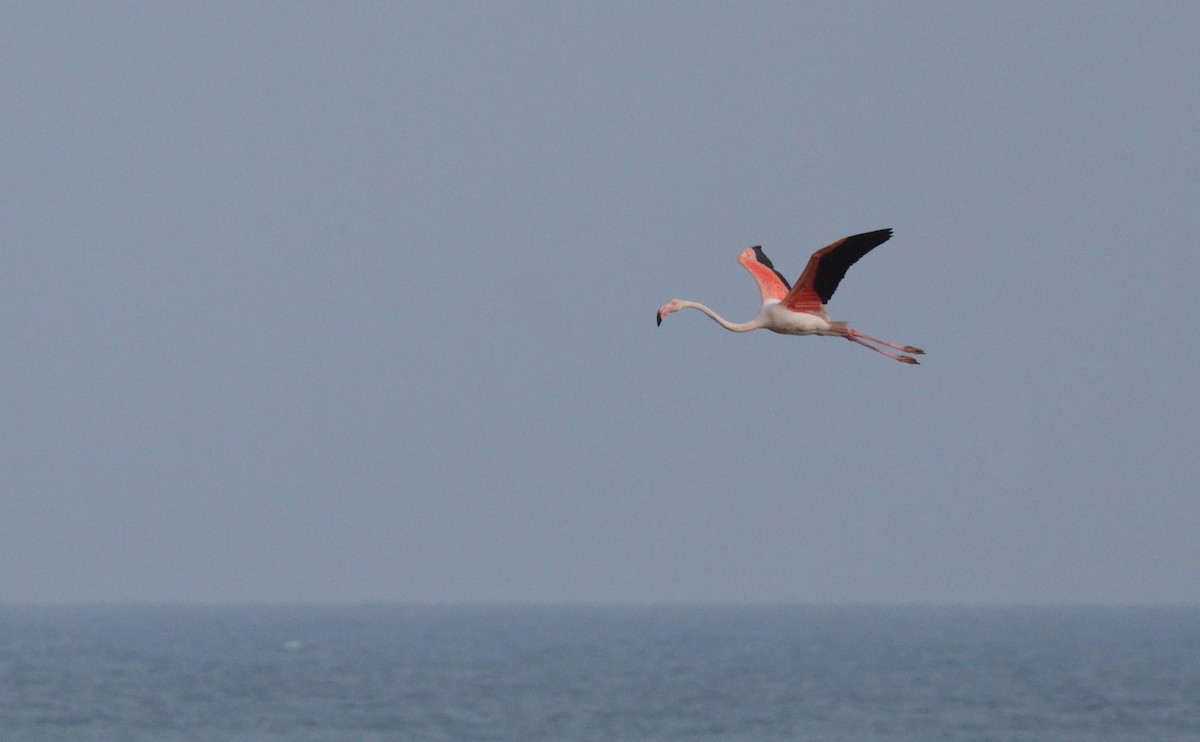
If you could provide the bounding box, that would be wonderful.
[658,229,924,364]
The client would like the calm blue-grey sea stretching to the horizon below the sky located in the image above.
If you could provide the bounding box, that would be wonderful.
[0,605,1200,742]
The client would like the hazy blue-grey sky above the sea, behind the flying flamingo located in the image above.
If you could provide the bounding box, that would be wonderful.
[0,2,1200,604]
